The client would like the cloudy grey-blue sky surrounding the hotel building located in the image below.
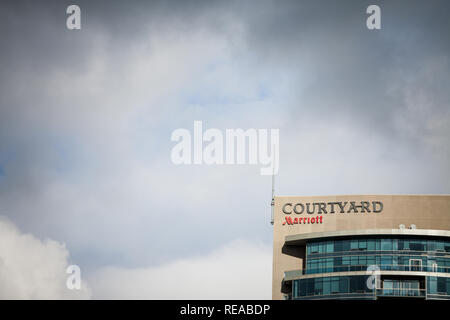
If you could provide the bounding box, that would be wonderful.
[0,0,450,299]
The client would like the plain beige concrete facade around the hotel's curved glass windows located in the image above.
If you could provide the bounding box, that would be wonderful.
[272,195,450,299]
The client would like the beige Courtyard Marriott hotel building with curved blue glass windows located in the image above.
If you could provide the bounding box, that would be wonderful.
[272,195,450,300]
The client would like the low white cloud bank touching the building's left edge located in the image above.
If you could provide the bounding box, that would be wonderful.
[89,240,272,299]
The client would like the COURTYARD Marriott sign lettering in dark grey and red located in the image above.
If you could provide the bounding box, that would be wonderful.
[282,201,383,225]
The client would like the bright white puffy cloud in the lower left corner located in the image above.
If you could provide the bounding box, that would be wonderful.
[0,217,91,299]
